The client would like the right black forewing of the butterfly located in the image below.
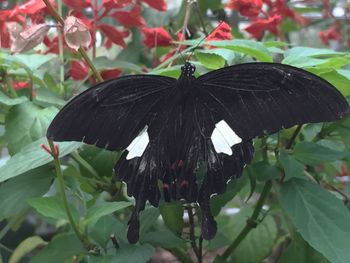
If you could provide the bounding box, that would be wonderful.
[198,63,349,138]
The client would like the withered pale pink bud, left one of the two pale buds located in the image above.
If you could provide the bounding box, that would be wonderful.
[10,24,50,53]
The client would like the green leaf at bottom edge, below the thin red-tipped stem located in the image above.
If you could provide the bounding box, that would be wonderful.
[30,234,86,263]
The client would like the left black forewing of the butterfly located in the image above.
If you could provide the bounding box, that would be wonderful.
[47,75,176,150]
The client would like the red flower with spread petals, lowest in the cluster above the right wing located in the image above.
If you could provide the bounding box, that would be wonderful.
[244,15,282,38]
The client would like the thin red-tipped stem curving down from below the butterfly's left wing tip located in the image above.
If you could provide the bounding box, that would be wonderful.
[48,139,91,249]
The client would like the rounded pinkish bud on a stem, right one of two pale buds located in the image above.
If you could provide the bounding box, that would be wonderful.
[64,16,91,50]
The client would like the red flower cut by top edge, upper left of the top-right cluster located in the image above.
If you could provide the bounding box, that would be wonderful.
[226,0,263,17]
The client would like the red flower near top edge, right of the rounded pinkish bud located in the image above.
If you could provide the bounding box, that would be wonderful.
[110,5,146,27]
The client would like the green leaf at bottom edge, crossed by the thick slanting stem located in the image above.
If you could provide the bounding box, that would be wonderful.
[220,208,277,263]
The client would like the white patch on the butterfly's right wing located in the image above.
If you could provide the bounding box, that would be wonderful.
[210,120,242,155]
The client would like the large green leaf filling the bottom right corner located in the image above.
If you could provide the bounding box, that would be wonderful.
[281,178,350,263]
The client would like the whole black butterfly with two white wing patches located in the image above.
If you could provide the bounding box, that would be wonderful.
[47,62,350,243]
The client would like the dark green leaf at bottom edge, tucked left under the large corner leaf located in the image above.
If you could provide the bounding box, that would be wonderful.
[278,234,329,263]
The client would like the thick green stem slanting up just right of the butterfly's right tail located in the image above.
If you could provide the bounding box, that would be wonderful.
[222,180,272,259]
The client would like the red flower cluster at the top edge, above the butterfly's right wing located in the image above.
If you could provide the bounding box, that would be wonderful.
[226,0,308,38]
